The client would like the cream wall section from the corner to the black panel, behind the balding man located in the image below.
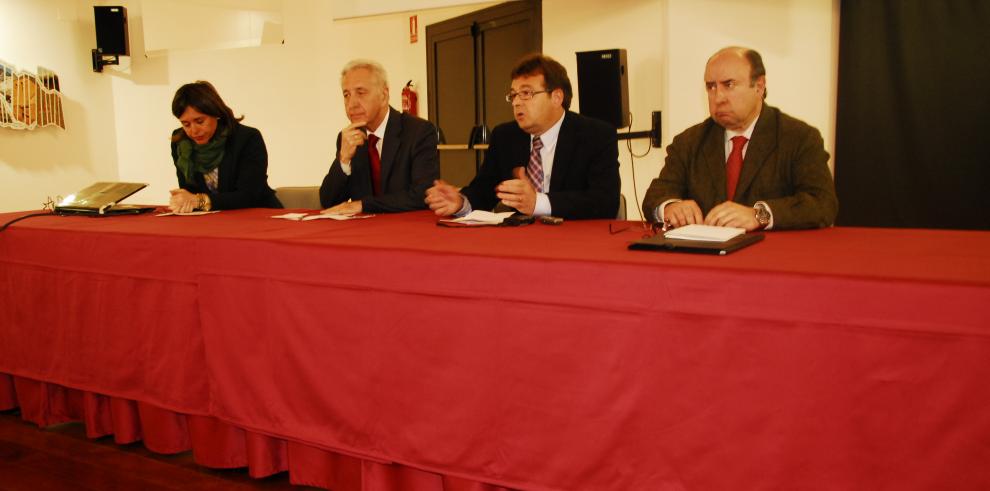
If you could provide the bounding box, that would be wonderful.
[664,0,839,172]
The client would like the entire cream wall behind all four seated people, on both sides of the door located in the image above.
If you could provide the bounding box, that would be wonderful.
[0,0,838,218]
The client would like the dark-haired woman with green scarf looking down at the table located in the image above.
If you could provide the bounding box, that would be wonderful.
[168,81,282,213]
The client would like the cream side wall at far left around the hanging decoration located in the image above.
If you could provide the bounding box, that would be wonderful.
[0,0,118,211]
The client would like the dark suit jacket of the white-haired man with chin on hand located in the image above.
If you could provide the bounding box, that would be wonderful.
[320,107,440,213]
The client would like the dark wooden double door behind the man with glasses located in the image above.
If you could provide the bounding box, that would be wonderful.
[426,0,543,186]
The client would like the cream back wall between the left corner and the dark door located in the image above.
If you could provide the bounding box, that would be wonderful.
[106,0,496,206]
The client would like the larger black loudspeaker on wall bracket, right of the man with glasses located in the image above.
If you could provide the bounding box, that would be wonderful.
[577,49,629,128]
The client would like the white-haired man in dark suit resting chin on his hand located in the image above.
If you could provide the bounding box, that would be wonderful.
[320,60,440,213]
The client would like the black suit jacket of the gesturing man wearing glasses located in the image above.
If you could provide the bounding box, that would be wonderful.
[461,111,619,219]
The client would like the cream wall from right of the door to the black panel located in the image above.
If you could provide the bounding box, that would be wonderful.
[543,0,838,219]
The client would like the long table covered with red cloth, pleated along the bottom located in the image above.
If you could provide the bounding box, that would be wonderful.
[0,209,990,490]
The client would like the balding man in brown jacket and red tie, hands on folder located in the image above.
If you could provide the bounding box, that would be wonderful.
[643,47,838,231]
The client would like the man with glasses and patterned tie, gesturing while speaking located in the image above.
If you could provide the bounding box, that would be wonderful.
[426,55,619,219]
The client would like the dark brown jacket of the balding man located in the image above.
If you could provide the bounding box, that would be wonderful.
[643,104,839,229]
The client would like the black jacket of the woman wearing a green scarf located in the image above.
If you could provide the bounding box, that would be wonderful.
[172,123,282,210]
